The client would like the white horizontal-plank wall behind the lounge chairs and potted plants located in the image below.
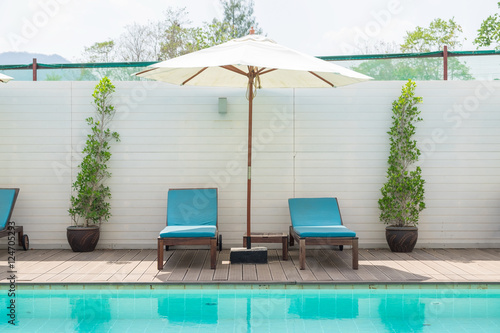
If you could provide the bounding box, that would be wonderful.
[0,81,500,248]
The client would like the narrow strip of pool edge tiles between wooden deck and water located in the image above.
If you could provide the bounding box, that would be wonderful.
[0,282,500,291]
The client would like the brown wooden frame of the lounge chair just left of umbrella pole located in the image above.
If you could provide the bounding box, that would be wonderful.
[158,188,222,271]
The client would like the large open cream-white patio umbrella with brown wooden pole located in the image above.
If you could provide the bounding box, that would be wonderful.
[135,31,371,249]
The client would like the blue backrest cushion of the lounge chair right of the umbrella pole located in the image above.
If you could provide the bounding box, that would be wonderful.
[288,198,342,228]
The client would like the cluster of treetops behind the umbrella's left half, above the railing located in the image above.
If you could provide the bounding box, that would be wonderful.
[83,0,262,62]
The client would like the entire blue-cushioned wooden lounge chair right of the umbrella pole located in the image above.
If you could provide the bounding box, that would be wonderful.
[288,198,358,269]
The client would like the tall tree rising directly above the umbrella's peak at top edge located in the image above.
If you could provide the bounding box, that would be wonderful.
[220,0,262,39]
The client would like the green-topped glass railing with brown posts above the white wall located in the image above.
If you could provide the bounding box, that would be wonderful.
[0,46,500,81]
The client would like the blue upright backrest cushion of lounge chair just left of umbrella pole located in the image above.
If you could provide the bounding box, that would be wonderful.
[167,188,217,226]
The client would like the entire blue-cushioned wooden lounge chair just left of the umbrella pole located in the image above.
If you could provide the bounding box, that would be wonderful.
[158,188,222,270]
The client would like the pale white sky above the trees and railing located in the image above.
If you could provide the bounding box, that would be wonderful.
[0,0,500,61]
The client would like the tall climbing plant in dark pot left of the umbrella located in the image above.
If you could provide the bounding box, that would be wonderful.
[67,77,120,252]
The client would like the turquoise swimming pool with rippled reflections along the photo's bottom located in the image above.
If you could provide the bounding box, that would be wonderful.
[0,285,500,333]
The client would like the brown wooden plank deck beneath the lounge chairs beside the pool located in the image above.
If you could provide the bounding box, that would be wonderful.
[0,247,500,283]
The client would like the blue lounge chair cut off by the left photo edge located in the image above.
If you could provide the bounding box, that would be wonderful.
[0,188,30,251]
